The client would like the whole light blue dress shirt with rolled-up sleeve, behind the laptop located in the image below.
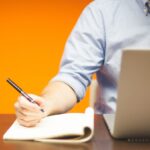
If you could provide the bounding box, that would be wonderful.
[53,0,150,113]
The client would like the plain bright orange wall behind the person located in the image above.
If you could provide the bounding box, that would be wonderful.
[0,0,90,113]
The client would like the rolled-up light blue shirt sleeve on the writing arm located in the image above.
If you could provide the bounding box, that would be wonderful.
[52,2,105,101]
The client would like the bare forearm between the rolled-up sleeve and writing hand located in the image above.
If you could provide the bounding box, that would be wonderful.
[41,81,77,115]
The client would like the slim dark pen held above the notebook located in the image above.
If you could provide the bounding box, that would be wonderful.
[6,78,44,112]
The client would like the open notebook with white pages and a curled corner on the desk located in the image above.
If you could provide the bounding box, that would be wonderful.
[3,108,94,143]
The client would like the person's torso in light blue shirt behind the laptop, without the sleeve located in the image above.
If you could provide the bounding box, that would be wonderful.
[95,0,150,113]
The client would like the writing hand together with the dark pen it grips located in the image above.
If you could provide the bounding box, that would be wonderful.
[7,79,46,127]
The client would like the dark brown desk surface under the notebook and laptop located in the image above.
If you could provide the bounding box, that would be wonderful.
[0,115,150,150]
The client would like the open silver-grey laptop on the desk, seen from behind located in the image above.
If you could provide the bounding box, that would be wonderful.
[104,49,150,139]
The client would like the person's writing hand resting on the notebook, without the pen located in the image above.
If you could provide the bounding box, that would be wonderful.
[14,94,44,127]
